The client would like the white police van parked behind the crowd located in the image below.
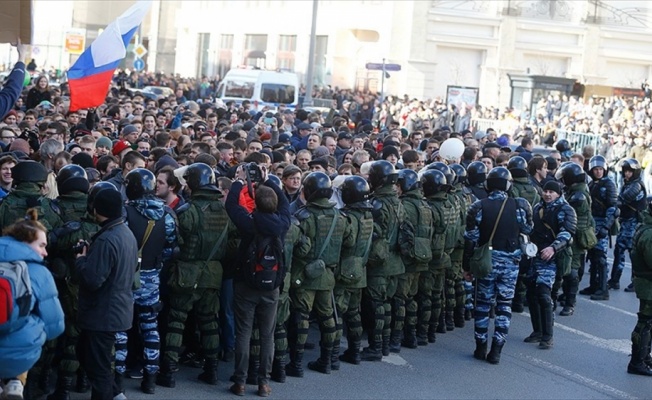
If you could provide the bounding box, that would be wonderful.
[217,69,299,110]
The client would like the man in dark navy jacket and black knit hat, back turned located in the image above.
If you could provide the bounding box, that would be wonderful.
[75,185,138,400]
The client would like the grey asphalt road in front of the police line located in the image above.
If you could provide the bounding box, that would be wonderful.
[73,250,640,399]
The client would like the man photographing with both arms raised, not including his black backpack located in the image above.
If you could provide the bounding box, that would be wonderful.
[225,166,290,396]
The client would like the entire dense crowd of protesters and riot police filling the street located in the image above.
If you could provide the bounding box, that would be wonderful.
[0,39,652,400]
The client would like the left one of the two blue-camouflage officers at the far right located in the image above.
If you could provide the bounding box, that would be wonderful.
[580,155,620,300]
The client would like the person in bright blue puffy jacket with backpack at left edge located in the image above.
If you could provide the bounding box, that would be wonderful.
[0,209,64,399]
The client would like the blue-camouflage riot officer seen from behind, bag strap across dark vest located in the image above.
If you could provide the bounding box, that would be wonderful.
[464,167,532,364]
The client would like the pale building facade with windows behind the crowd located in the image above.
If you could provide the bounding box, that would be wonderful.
[11,0,652,106]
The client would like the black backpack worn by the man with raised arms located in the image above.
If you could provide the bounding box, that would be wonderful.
[244,234,285,292]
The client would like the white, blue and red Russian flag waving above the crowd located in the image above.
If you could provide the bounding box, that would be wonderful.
[68,0,152,111]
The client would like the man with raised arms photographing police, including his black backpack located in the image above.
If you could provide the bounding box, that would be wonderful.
[225,162,291,397]
